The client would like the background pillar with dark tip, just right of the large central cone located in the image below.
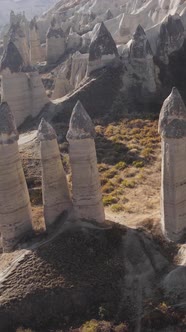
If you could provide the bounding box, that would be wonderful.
[129,25,156,94]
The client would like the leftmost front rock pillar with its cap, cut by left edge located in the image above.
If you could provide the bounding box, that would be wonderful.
[0,103,32,252]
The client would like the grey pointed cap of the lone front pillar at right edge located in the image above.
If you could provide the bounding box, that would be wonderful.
[158,88,186,138]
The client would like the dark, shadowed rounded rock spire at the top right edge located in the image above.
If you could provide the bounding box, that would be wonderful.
[157,15,184,64]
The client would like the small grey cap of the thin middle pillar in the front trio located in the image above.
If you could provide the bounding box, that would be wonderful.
[37,118,57,141]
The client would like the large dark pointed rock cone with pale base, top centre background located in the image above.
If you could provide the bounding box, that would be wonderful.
[88,22,118,74]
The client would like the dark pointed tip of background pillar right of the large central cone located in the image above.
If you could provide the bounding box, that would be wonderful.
[129,24,153,59]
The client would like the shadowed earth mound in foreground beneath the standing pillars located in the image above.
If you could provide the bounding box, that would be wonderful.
[0,221,185,332]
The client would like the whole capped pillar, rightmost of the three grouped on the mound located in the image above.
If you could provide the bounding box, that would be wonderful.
[67,101,105,223]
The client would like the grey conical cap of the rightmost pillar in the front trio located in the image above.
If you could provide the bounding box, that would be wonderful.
[67,101,95,140]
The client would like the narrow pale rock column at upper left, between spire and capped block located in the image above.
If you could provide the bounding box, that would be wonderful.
[29,18,42,65]
